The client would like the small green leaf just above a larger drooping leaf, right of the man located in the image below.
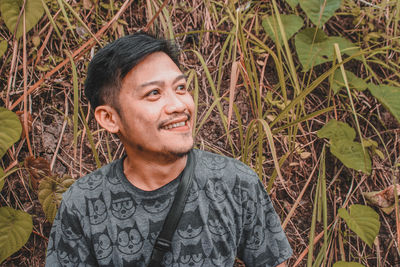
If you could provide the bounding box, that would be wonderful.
[317,119,356,142]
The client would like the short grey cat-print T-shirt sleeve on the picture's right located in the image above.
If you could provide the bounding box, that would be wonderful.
[238,179,292,267]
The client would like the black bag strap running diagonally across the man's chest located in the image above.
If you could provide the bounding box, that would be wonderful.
[148,150,195,267]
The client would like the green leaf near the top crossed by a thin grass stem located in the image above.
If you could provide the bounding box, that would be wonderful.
[262,15,304,44]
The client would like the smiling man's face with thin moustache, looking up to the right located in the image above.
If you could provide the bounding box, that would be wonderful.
[118,52,194,159]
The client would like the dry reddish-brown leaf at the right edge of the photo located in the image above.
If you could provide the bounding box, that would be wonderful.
[363,185,400,214]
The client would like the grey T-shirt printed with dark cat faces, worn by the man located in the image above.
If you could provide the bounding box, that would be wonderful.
[46,149,292,267]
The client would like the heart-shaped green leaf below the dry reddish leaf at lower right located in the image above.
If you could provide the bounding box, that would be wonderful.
[338,204,381,247]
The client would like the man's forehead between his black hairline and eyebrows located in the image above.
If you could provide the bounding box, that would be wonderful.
[122,52,182,87]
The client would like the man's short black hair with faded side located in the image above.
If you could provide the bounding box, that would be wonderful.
[85,32,179,112]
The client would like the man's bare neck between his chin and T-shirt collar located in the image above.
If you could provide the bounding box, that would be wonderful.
[123,150,187,191]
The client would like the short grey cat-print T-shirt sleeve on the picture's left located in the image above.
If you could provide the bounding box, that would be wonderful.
[46,198,97,267]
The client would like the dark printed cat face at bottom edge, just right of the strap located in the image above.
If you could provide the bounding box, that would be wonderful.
[178,240,207,267]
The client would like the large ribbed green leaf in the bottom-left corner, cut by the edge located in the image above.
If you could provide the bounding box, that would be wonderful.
[0,207,33,263]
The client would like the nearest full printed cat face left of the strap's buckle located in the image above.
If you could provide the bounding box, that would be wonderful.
[117,222,144,255]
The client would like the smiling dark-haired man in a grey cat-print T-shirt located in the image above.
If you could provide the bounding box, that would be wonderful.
[46,33,292,266]
